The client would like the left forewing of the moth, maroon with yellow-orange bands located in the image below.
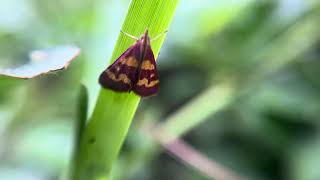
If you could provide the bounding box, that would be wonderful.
[99,42,140,92]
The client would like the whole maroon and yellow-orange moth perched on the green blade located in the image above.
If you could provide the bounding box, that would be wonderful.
[99,29,166,97]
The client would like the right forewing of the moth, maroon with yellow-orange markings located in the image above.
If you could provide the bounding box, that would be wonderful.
[133,45,159,97]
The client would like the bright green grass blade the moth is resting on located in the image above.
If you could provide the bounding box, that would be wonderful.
[74,0,179,180]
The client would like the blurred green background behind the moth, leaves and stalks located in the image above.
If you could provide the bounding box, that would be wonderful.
[0,0,320,180]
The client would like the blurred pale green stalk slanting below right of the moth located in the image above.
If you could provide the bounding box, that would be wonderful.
[157,82,234,143]
